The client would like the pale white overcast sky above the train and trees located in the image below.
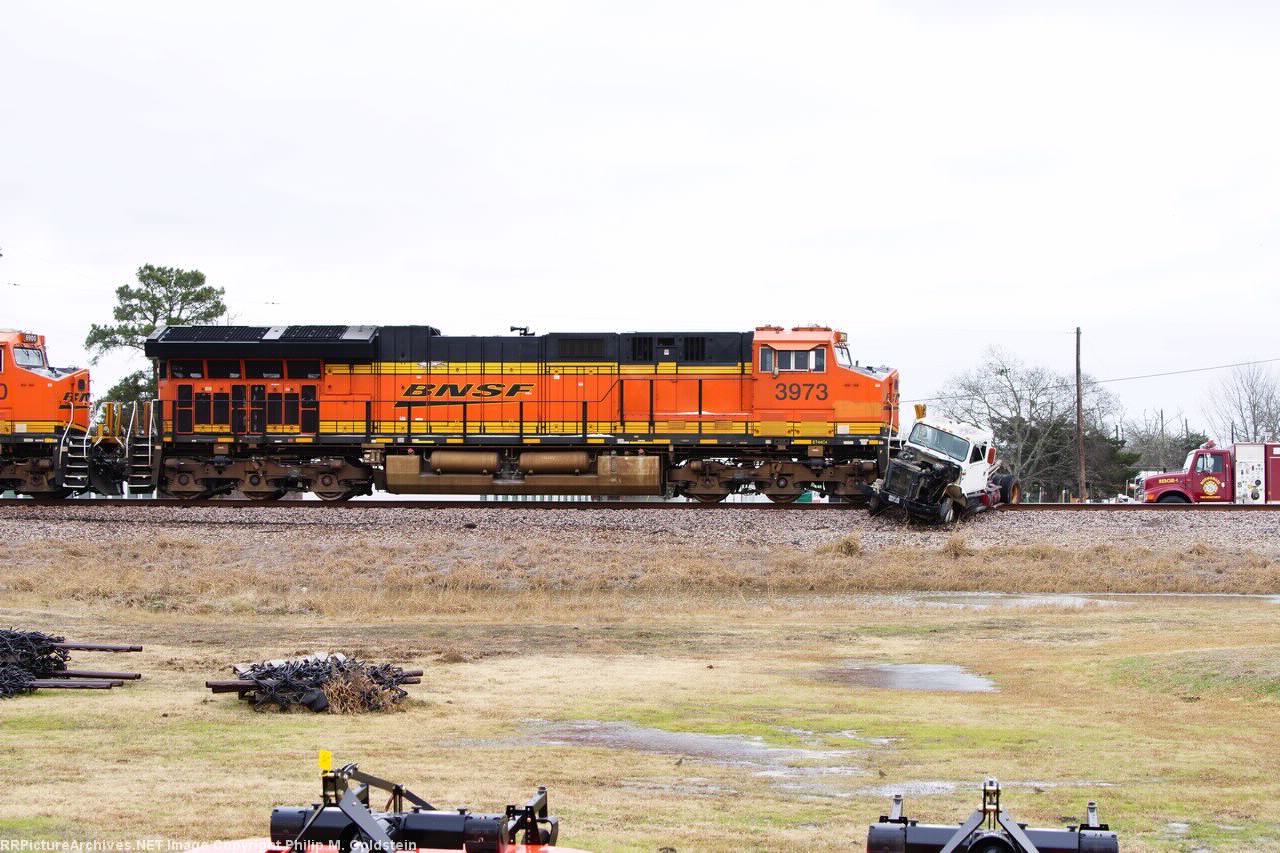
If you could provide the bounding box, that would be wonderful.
[0,0,1280,438]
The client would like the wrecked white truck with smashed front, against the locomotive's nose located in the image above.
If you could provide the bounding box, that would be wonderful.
[868,416,1021,524]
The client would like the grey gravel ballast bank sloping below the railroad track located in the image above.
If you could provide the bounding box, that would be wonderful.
[0,502,1280,557]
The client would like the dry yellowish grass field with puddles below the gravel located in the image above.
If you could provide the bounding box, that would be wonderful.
[0,502,1280,853]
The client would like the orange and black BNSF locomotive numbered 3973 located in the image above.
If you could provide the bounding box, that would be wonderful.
[131,325,897,502]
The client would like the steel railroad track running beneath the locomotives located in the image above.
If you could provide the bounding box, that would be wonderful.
[0,498,1280,512]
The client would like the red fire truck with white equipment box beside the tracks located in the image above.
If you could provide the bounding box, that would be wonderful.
[1143,442,1280,503]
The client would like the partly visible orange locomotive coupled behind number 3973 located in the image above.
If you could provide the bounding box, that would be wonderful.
[0,329,90,498]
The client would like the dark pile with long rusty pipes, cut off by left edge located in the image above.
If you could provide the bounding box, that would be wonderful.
[0,629,142,699]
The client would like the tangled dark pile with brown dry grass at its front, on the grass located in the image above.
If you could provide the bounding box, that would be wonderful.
[205,653,422,713]
